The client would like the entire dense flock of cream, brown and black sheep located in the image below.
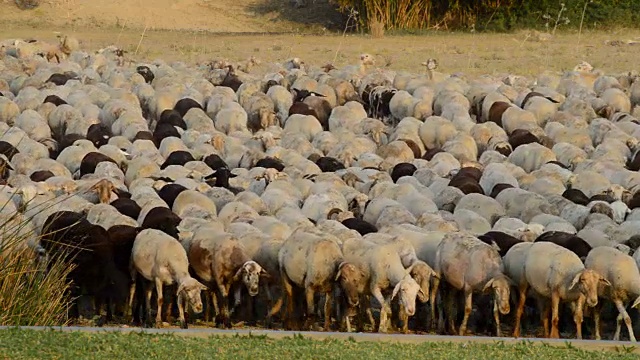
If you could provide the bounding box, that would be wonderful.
[0,36,640,340]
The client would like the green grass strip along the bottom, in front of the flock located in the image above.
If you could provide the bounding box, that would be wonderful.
[0,330,638,360]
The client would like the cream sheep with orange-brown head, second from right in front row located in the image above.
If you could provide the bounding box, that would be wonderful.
[519,242,611,339]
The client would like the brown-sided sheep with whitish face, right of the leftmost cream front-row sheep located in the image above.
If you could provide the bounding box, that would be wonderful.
[187,228,266,328]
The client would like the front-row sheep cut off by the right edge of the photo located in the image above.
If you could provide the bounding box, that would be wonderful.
[584,246,640,342]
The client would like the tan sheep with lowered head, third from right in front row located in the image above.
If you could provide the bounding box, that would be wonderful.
[432,233,512,336]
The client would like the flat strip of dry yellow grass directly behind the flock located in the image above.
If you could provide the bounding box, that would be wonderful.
[0,23,640,76]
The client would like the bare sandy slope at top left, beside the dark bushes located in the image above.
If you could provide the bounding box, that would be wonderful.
[0,0,340,33]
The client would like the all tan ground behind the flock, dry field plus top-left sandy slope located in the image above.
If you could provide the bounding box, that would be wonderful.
[0,0,640,75]
